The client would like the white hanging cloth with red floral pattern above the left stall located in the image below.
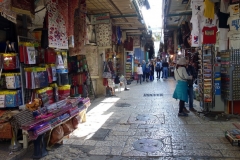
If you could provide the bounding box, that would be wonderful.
[47,0,68,49]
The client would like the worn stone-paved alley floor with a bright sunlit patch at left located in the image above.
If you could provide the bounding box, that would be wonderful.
[13,78,240,160]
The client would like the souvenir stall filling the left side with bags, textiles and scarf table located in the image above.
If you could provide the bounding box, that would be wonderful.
[0,0,92,159]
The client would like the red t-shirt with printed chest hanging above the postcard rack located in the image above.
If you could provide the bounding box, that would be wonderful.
[202,26,217,44]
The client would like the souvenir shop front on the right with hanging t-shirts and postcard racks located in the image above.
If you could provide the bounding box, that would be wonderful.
[174,0,240,114]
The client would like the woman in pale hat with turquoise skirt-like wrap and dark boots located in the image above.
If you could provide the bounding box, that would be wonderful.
[173,57,192,116]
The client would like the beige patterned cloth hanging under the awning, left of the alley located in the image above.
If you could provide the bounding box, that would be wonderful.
[96,24,112,48]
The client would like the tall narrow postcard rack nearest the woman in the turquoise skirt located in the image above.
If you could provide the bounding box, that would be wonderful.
[198,45,215,111]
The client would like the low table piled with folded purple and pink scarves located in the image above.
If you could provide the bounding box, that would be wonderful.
[11,97,91,151]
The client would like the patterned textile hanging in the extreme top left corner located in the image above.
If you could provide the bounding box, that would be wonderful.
[0,0,17,23]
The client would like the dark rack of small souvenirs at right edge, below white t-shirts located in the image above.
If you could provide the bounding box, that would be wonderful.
[221,49,240,101]
